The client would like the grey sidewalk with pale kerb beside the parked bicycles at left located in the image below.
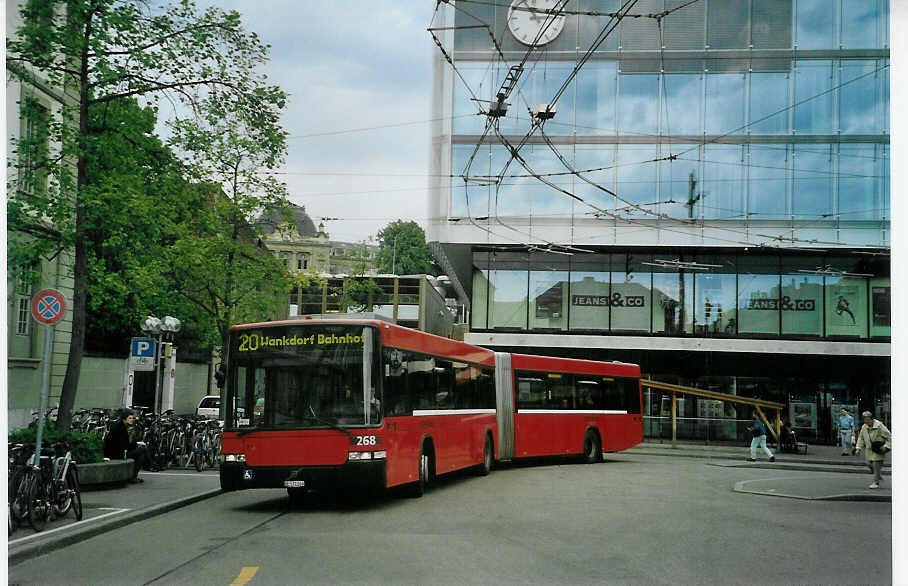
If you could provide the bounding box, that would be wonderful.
[7,468,221,565]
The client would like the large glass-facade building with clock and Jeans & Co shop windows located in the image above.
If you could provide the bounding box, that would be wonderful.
[428,0,890,438]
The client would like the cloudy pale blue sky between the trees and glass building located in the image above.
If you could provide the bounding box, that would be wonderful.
[198,0,435,242]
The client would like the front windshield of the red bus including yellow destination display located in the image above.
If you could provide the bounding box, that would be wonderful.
[227,323,382,430]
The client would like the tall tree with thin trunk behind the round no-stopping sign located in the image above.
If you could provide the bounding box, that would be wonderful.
[6,0,285,426]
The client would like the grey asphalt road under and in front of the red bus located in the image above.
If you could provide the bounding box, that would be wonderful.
[9,454,892,586]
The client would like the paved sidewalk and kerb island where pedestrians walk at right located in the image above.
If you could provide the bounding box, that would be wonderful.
[624,441,892,502]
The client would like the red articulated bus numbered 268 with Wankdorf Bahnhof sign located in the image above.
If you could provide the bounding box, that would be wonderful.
[220,316,643,498]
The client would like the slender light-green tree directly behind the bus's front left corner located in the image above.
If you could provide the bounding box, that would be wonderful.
[158,92,293,354]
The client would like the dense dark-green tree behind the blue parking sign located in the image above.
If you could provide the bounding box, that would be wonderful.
[86,98,210,351]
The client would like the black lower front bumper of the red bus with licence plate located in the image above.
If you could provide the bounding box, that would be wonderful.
[220,460,387,490]
